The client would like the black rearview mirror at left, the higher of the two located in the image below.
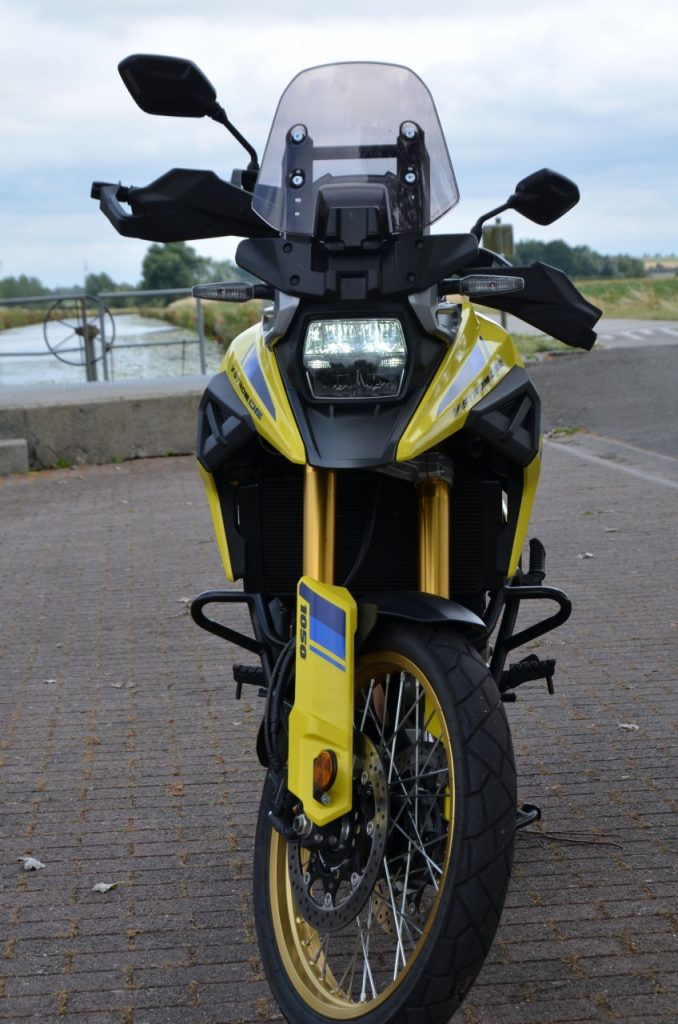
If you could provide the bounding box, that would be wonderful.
[118,53,216,118]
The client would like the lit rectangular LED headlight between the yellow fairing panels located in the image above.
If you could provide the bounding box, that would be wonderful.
[303,317,408,400]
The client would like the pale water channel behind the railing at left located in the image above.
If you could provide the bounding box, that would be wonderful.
[0,313,228,388]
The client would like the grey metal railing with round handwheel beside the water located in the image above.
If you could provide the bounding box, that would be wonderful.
[0,288,207,381]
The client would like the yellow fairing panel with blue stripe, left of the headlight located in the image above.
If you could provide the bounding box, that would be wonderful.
[221,324,306,465]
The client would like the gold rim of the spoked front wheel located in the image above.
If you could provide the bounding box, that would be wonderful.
[268,651,455,1021]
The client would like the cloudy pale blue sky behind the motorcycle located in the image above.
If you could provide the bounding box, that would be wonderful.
[0,0,678,286]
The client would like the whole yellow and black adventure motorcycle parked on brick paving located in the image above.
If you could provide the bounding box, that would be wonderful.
[92,54,599,1024]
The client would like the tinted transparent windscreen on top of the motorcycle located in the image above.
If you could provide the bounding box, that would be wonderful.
[252,62,459,237]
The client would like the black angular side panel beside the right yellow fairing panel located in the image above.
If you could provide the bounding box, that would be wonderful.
[465,364,541,467]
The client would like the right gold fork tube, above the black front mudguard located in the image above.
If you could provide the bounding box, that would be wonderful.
[417,477,450,597]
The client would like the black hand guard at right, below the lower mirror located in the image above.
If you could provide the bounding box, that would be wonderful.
[464,263,602,351]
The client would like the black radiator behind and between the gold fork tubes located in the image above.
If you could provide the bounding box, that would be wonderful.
[238,470,501,596]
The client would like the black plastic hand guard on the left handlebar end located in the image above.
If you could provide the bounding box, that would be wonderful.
[91,168,278,242]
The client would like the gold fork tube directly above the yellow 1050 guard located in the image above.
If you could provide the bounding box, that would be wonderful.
[303,466,337,584]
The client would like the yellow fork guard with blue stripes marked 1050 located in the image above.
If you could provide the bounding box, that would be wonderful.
[288,575,357,825]
